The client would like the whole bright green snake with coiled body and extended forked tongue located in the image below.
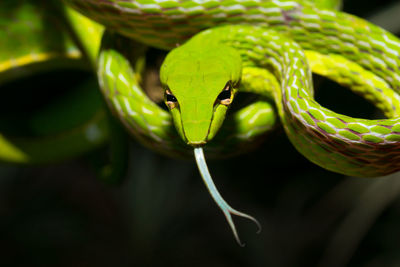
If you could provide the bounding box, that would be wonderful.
[2,0,400,247]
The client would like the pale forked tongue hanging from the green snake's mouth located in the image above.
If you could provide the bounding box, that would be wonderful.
[194,147,261,247]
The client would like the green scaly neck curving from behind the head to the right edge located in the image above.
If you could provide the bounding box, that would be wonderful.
[190,25,400,176]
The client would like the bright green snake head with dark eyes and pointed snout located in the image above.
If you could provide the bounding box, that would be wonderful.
[160,43,242,146]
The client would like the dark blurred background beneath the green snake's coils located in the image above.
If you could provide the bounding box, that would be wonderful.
[0,0,400,267]
